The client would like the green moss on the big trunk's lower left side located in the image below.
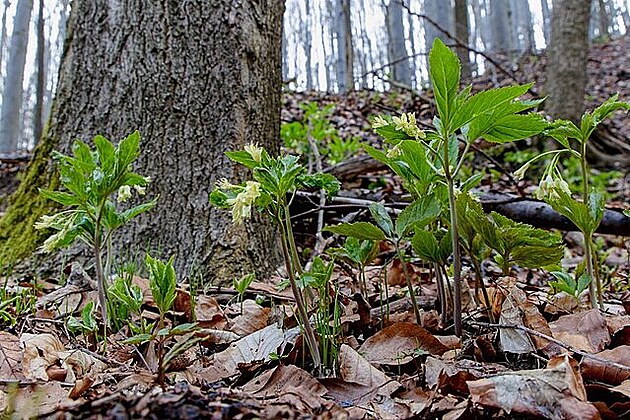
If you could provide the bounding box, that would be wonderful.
[0,136,59,261]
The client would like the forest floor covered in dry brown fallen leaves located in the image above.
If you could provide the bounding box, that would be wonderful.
[0,37,630,420]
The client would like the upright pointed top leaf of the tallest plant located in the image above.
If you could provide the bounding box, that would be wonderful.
[429,38,460,128]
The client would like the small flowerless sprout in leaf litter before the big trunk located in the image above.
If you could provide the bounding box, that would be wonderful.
[125,254,202,387]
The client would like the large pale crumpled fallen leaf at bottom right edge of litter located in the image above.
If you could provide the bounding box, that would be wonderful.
[468,355,601,420]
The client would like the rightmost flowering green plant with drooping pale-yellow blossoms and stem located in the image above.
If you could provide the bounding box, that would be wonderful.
[516,95,630,309]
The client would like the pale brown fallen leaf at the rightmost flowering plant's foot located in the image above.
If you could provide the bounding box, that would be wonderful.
[549,309,610,353]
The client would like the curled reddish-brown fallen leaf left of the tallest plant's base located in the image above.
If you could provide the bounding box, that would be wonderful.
[359,322,448,365]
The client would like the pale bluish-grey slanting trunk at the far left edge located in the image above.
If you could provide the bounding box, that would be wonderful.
[0,0,33,153]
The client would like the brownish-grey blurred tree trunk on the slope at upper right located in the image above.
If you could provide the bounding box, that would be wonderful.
[545,0,590,121]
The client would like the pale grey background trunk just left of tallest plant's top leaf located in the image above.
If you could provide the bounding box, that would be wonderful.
[385,0,411,86]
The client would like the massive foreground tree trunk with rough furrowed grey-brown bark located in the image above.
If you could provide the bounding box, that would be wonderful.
[0,0,284,283]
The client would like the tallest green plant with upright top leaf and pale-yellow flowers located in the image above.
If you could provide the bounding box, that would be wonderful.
[366,39,547,335]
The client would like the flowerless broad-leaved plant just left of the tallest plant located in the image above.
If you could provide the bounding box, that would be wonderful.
[324,199,441,323]
